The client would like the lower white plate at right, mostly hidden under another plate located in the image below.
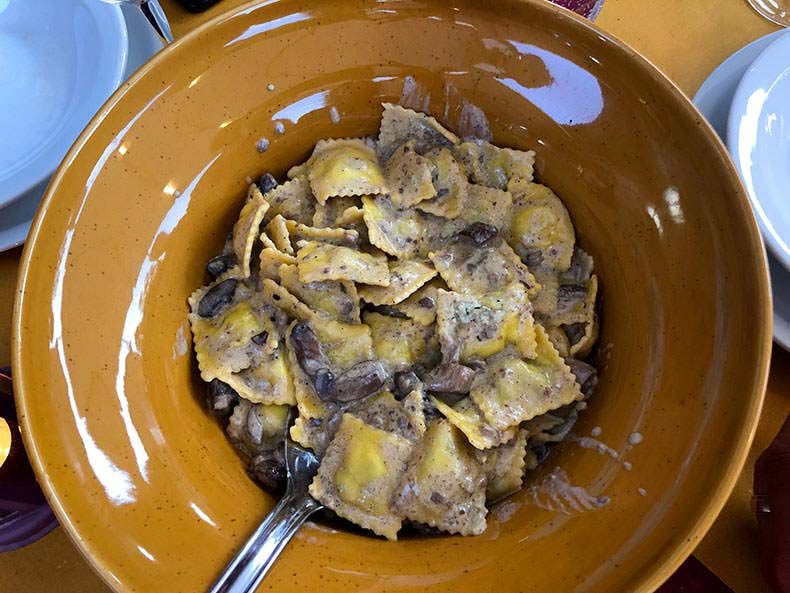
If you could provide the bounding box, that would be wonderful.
[694,31,790,350]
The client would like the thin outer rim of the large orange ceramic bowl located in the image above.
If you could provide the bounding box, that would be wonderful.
[11,0,773,593]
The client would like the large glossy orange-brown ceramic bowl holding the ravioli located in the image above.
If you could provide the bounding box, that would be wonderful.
[14,0,771,593]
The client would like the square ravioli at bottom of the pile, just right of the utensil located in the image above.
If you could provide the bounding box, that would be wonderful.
[310,414,413,540]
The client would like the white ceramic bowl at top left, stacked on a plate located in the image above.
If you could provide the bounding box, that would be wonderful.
[0,0,129,208]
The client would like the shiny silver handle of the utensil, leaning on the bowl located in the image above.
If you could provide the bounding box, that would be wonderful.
[208,492,323,593]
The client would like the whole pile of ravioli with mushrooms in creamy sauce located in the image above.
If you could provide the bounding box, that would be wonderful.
[189,104,599,540]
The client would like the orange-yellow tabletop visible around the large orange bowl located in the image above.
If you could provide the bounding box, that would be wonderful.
[0,0,790,593]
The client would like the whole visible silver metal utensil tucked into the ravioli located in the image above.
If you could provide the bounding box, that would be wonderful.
[208,430,323,593]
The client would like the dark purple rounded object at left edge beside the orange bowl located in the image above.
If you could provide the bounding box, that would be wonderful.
[0,368,58,552]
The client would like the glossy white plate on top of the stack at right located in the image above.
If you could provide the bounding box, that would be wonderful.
[727,31,790,270]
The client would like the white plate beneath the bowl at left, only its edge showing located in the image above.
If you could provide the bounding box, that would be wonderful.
[0,6,162,251]
